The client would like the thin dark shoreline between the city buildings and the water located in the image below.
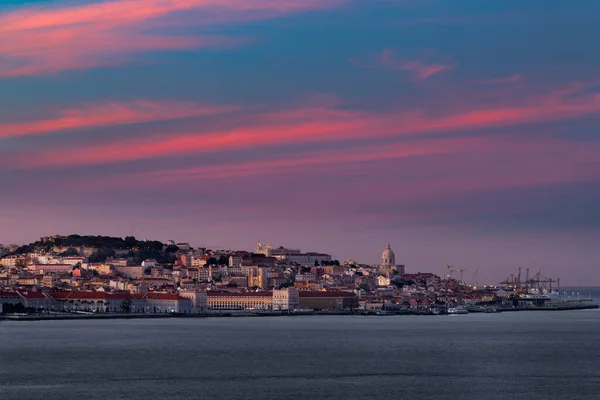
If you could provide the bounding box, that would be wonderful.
[0,304,600,321]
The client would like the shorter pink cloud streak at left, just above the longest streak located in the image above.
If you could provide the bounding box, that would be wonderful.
[0,100,237,139]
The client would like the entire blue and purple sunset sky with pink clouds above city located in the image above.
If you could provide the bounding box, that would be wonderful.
[0,0,600,286]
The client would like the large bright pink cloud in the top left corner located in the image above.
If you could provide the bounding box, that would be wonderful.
[0,0,344,77]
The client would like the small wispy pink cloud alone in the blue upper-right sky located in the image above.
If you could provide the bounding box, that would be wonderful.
[350,49,451,81]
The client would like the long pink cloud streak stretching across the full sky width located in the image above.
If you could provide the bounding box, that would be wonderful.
[3,83,600,168]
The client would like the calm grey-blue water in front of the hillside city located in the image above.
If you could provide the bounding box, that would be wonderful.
[0,310,600,400]
